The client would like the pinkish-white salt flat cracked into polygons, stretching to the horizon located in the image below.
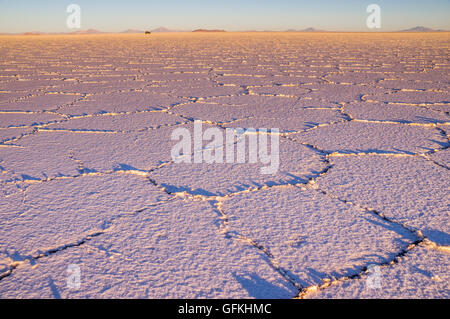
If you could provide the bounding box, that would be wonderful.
[0,33,450,298]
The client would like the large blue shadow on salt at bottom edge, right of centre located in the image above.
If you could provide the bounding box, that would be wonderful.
[233,273,292,299]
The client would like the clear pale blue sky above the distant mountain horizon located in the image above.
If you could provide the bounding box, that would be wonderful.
[0,0,450,33]
